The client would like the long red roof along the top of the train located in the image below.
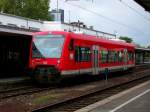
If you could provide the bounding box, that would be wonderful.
[34,31,135,48]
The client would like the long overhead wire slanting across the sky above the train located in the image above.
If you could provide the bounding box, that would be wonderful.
[65,2,144,34]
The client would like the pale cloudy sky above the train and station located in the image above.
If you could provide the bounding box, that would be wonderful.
[50,0,150,46]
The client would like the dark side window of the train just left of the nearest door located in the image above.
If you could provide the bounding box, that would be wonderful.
[75,46,91,62]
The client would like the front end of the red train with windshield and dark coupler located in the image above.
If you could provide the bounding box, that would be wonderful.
[30,32,65,83]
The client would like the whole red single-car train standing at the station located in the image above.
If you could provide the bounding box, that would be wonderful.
[30,31,135,83]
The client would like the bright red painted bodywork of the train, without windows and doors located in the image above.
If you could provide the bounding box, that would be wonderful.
[30,31,135,74]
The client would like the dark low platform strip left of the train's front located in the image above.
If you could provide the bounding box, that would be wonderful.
[0,76,30,85]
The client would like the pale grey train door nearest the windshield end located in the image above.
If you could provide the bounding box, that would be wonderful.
[92,45,99,74]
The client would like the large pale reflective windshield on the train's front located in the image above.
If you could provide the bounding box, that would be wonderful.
[32,34,64,58]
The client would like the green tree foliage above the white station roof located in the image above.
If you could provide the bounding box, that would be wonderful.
[0,0,50,20]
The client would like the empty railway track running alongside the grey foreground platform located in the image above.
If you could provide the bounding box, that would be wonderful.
[42,77,150,112]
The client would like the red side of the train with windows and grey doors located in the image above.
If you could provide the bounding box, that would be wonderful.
[58,34,135,75]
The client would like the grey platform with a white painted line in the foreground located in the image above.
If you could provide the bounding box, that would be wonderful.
[75,81,150,112]
